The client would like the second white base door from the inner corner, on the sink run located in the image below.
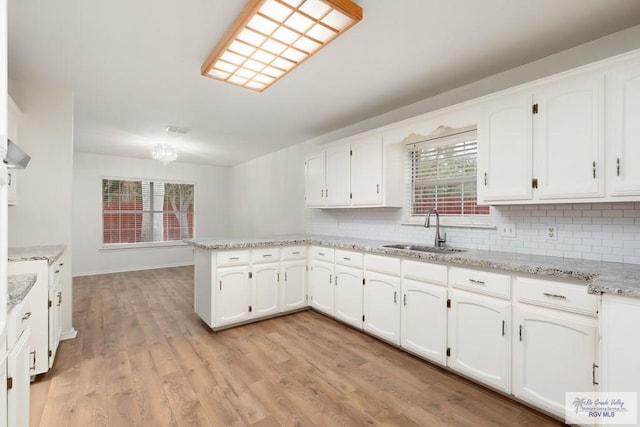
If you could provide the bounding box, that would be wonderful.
[334,265,362,329]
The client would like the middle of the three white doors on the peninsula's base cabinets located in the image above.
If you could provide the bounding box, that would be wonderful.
[253,262,280,317]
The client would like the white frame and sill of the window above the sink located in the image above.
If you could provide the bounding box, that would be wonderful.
[402,126,495,228]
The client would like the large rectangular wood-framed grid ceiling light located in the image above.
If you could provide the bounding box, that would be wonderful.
[201,0,362,92]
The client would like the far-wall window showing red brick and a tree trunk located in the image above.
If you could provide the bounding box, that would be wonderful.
[102,179,194,244]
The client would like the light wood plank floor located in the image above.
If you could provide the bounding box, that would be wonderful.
[31,267,560,427]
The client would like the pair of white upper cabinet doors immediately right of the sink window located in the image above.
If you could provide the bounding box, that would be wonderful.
[478,72,604,204]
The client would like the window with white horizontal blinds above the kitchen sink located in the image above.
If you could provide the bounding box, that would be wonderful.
[406,130,489,218]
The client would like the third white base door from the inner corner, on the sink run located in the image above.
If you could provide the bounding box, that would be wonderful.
[363,271,400,345]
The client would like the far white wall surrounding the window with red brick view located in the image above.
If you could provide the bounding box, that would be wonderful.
[73,153,230,276]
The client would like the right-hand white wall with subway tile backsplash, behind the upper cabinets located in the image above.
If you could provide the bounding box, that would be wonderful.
[231,26,640,263]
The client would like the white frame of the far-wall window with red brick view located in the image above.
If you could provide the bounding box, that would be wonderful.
[98,176,196,250]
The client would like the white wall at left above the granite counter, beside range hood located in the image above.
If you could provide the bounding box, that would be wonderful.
[9,80,73,333]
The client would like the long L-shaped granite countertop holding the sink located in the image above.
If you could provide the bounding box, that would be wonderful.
[186,234,640,297]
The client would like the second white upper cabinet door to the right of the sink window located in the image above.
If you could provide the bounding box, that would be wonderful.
[533,75,605,199]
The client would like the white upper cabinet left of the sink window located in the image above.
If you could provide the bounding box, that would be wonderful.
[305,134,404,208]
